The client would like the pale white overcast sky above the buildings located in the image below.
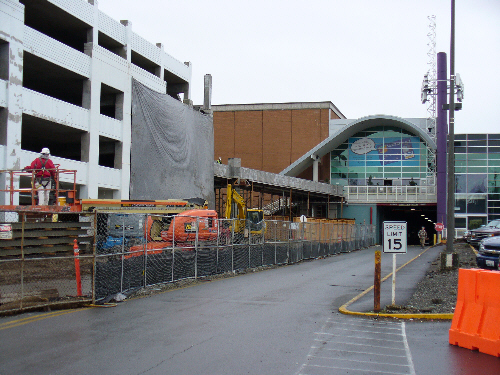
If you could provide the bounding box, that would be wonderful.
[99,0,500,133]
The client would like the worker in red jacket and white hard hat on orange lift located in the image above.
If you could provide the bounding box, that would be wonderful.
[23,147,56,206]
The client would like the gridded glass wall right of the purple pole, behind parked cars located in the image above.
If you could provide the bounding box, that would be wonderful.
[455,134,500,229]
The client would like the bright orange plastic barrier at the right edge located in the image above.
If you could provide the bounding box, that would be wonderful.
[449,269,500,357]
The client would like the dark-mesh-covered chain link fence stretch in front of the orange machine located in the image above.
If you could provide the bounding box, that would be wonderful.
[94,214,375,300]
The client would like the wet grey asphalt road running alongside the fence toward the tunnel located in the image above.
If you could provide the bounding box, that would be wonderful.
[0,247,500,375]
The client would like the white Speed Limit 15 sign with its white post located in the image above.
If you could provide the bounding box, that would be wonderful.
[383,221,407,305]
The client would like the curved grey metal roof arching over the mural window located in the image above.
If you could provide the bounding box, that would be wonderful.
[280,115,437,176]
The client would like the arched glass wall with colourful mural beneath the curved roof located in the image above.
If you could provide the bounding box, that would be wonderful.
[330,126,428,186]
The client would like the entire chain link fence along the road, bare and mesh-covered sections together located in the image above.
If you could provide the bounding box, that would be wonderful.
[0,210,375,313]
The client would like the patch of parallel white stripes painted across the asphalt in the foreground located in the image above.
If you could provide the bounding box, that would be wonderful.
[296,316,415,375]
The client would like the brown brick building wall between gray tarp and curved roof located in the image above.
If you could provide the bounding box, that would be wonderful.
[213,102,343,180]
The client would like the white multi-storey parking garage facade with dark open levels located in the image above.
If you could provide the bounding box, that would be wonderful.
[0,0,192,204]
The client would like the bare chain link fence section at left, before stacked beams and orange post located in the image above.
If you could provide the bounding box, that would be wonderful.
[0,212,94,313]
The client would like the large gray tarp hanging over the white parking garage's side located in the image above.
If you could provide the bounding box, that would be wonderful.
[130,80,215,207]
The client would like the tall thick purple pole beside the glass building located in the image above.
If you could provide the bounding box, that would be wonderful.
[436,52,448,227]
